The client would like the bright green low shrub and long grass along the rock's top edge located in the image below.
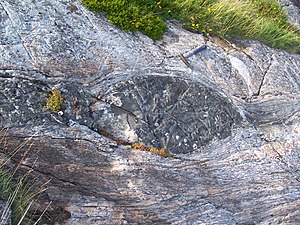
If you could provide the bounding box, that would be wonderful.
[82,0,300,53]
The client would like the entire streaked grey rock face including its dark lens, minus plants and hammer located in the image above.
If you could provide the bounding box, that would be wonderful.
[0,0,300,224]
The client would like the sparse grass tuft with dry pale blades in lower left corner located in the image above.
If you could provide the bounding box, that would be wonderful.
[0,129,50,225]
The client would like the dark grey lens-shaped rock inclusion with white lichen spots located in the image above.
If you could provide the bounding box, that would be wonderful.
[101,76,241,154]
